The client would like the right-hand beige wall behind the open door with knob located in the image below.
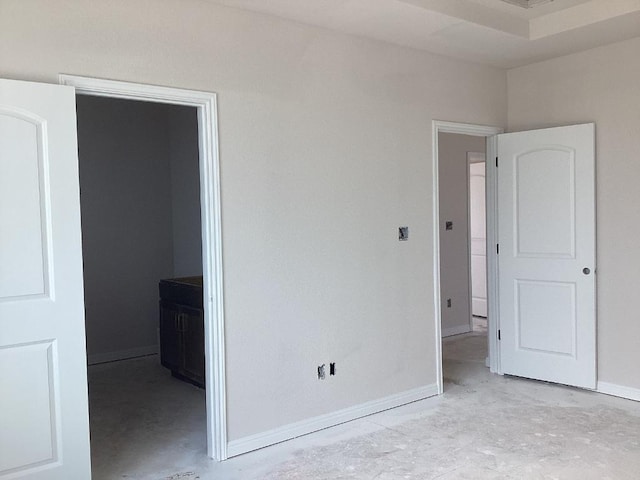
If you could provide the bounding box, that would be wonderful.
[508,38,640,398]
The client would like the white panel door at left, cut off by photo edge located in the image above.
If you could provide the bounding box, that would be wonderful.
[0,80,91,480]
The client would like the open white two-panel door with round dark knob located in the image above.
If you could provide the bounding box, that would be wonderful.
[498,124,596,388]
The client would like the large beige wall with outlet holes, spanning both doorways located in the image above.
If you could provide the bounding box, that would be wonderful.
[0,0,506,440]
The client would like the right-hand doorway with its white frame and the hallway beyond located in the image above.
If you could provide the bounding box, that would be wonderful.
[433,121,502,393]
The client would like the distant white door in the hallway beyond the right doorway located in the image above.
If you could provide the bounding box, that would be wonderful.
[467,156,487,317]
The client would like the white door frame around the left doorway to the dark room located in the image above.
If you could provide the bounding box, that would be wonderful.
[59,74,227,461]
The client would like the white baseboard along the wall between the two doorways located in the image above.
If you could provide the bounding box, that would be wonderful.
[227,384,438,457]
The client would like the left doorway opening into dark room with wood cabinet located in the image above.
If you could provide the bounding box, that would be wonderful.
[76,95,206,478]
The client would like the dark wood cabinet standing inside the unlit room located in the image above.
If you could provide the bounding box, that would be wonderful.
[159,277,205,388]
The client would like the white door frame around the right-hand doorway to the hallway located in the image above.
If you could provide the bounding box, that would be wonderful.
[432,120,504,394]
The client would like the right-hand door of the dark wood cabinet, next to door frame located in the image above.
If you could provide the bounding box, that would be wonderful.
[180,306,204,386]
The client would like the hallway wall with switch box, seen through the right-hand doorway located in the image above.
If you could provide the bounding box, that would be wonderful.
[438,133,485,336]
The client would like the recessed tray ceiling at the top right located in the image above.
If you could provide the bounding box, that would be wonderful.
[209,0,640,68]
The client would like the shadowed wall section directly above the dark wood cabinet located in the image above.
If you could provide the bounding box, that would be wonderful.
[166,106,202,277]
